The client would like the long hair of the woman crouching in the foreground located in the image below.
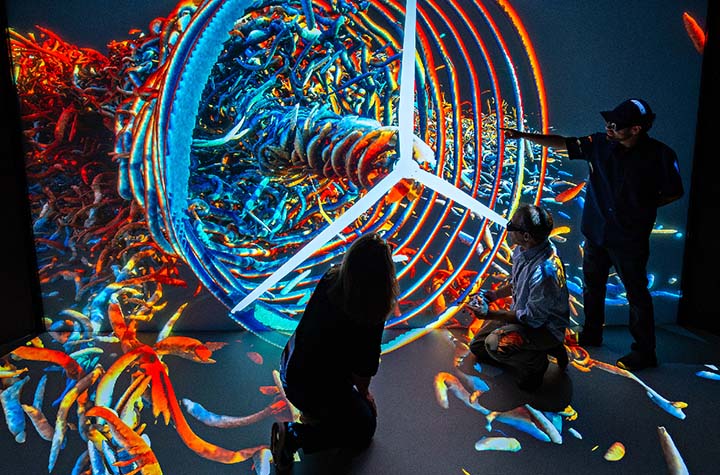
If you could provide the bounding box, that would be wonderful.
[330,233,400,324]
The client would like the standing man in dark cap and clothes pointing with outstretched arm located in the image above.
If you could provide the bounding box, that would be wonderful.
[505,98,683,371]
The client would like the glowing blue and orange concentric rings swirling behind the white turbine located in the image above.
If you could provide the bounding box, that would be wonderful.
[116,0,547,350]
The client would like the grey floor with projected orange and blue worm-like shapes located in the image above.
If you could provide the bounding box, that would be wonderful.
[0,327,720,475]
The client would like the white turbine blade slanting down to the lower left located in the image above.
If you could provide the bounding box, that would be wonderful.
[231,171,403,313]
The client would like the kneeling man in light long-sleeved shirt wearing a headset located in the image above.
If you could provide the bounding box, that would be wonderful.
[466,205,570,391]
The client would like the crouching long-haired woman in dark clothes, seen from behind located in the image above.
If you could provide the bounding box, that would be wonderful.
[271,233,399,472]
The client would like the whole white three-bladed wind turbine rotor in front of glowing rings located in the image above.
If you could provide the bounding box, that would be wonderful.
[231,0,507,313]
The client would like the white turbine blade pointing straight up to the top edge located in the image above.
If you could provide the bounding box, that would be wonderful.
[398,0,417,162]
